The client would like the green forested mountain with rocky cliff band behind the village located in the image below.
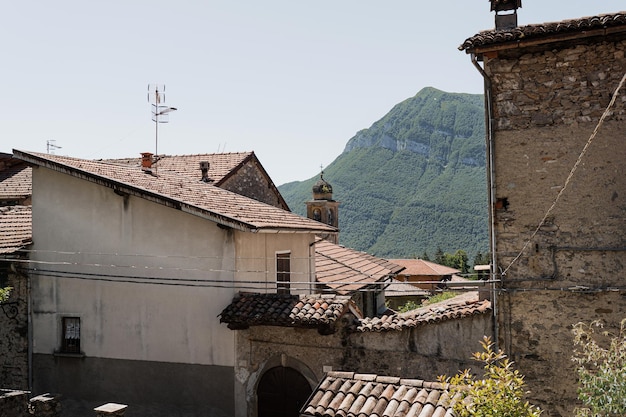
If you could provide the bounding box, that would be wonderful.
[278,87,489,259]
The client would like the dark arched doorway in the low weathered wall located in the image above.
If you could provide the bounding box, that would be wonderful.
[257,366,313,417]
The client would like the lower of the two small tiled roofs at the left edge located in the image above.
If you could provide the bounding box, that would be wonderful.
[0,206,33,254]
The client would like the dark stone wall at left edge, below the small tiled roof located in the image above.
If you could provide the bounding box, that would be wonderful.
[0,262,29,389]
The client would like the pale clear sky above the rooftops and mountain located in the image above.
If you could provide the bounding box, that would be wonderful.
[0,0,625,185]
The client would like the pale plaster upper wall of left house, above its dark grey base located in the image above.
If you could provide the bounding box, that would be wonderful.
[31,167,240,366]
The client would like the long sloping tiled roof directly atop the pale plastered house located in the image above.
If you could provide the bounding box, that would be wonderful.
[14,150,336,232]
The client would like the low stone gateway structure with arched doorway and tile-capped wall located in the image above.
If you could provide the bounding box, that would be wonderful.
[220,292,491,417]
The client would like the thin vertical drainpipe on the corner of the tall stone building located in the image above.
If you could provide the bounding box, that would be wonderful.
[471,53,499,351]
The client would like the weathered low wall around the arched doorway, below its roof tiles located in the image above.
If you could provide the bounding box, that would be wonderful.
[235,314,491,417]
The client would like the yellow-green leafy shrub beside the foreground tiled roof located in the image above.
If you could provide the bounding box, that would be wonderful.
[439,336,541,417]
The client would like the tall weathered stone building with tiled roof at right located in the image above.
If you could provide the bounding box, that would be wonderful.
[460,8,626,416]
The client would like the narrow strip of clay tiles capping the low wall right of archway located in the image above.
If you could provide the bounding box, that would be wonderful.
[356,291,491,332]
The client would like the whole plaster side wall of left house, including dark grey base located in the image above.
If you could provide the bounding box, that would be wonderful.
[30,168,244,417]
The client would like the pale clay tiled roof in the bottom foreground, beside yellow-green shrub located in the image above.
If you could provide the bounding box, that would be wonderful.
[300,372,460,417]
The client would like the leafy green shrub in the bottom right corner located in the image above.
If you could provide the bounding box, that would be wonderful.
[572,319,626,417]
